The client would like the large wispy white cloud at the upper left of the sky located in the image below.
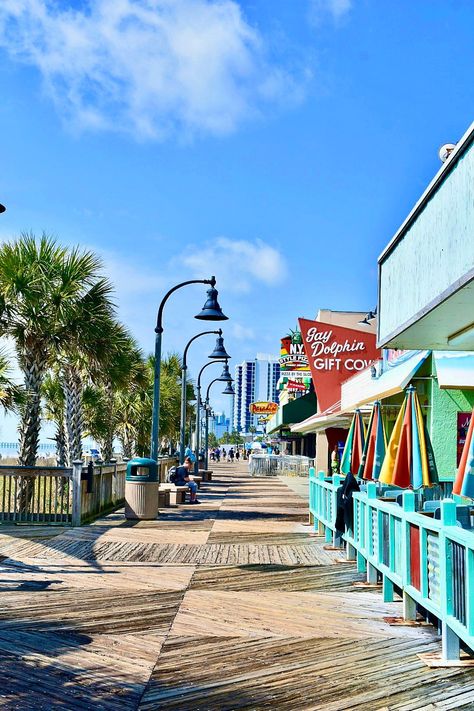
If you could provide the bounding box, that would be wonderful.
[0,0,310,139]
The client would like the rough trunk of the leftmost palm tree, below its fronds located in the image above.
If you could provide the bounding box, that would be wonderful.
[17,353,46,512]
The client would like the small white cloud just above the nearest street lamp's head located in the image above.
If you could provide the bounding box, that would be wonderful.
[178,237,287,293]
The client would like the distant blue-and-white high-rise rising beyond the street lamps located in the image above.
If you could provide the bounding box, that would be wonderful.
[232,353,280,432]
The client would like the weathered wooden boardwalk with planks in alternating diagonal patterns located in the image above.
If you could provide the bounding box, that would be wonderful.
[0,464,474,711]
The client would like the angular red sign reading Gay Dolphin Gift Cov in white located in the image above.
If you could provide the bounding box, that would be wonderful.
[299,318,381,411]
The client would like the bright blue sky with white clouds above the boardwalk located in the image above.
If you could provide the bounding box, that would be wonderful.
[0,0,474,437]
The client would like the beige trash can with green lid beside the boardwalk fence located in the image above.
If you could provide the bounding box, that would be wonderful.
[125,457,159,520]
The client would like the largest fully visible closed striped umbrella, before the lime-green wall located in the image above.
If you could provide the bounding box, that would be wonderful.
[379,386,438,489]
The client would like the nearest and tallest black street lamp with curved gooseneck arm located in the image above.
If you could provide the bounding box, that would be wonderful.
[150,276,227,461]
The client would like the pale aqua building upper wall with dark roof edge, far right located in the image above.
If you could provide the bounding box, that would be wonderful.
[377,123,474,351]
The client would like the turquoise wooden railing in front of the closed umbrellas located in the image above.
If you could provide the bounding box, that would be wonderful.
[310,471,474,660]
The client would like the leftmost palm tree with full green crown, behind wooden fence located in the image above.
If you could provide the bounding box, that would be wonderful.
[0,234,113,505]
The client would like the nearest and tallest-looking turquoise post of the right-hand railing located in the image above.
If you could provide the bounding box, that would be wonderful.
[439,499,459,659]
